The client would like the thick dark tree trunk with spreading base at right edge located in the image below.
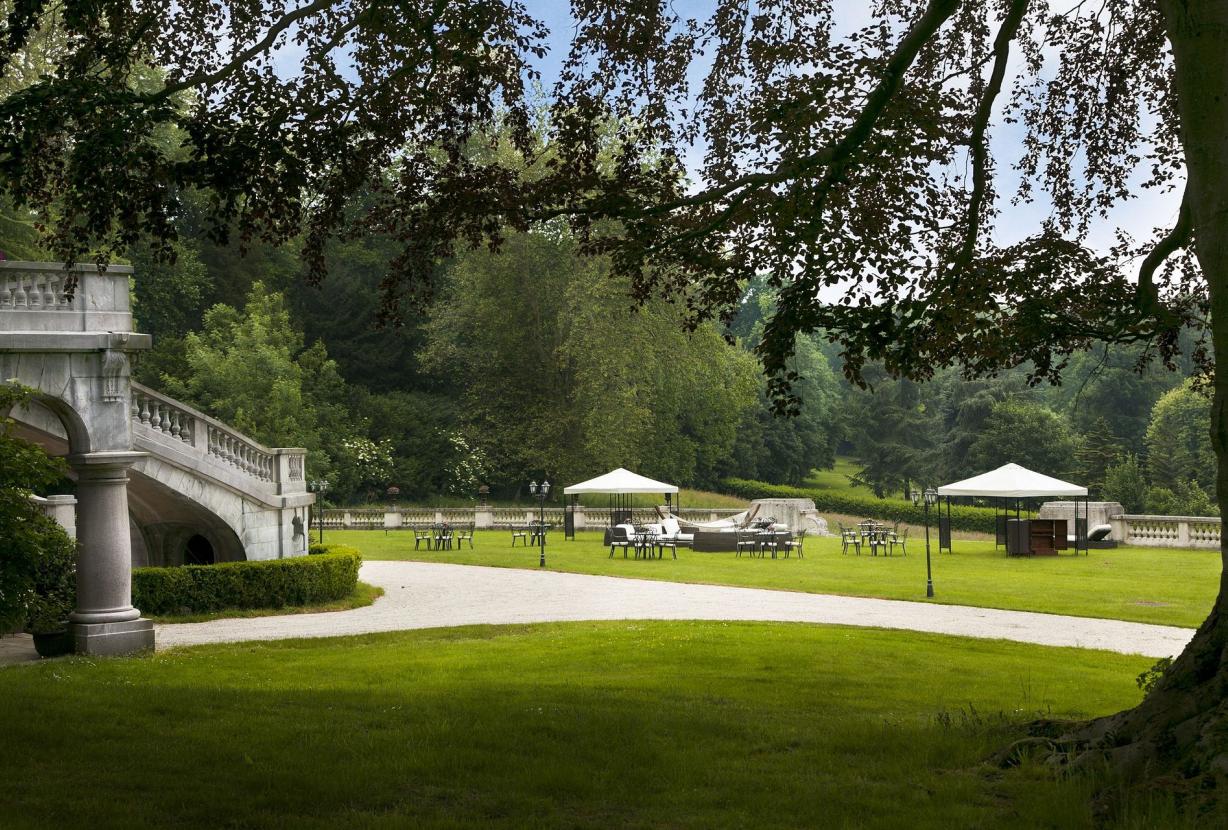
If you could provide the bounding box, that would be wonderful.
[997,0,1228,808]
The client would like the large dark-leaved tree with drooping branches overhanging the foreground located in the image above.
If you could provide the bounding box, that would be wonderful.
[7,0,1228,810]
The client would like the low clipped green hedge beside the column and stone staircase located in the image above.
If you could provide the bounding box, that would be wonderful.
[133,545,362,614]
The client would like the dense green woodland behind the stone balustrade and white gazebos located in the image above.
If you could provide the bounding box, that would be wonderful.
[0,191,1214,514]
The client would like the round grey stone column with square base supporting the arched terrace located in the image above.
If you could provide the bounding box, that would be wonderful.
[69,452,154,654]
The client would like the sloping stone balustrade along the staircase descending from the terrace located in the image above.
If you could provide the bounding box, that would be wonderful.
[129,383,307,495]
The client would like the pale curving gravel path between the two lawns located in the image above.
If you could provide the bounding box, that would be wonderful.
[141,561,1194,657]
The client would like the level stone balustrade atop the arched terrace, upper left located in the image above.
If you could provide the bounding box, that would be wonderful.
[0,262,133,332]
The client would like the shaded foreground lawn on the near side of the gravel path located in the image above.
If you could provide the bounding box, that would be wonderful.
[0,623,1169,830]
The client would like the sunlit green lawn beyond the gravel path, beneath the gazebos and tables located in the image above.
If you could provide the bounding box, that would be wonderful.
[327,530,1221,627]
